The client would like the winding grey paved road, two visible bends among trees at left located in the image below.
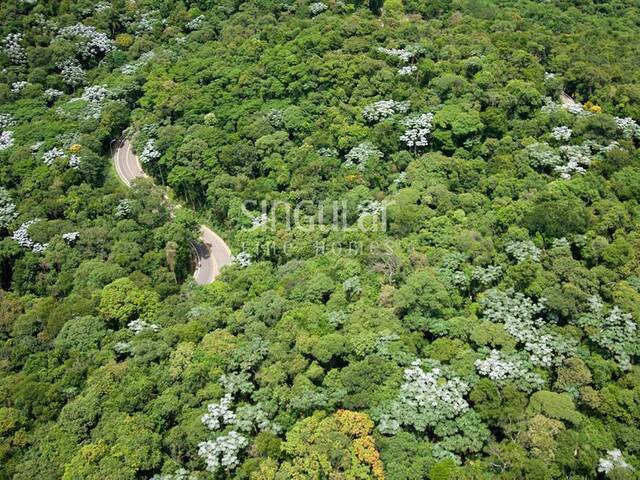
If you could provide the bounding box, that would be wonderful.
[113,139,231,285]
